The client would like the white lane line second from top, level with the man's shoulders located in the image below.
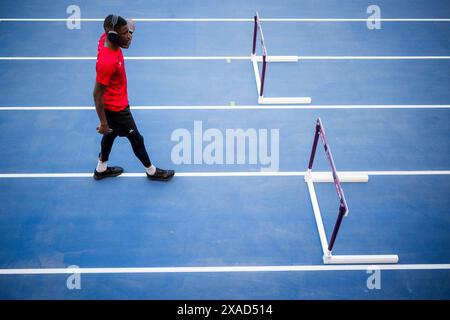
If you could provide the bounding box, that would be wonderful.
[0,56,450,61]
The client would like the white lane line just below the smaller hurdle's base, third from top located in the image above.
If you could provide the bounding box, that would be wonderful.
[0,104,450,111]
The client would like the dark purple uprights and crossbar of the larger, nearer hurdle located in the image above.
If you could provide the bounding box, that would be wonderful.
[308,118,348,252]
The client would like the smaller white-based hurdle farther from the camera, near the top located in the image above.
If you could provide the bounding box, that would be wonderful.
[251,12,311,104]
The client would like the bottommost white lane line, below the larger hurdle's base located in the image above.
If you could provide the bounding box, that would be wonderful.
[0,264,450,275]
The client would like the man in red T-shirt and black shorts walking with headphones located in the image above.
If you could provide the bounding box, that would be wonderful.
[94,15,175,181]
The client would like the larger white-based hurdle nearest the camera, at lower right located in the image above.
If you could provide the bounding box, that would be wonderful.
[305,118,399,264]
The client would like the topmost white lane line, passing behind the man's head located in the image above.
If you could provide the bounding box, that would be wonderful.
[0,18,450,22]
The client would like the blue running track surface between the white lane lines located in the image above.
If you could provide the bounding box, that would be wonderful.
[0,0,450,299]
